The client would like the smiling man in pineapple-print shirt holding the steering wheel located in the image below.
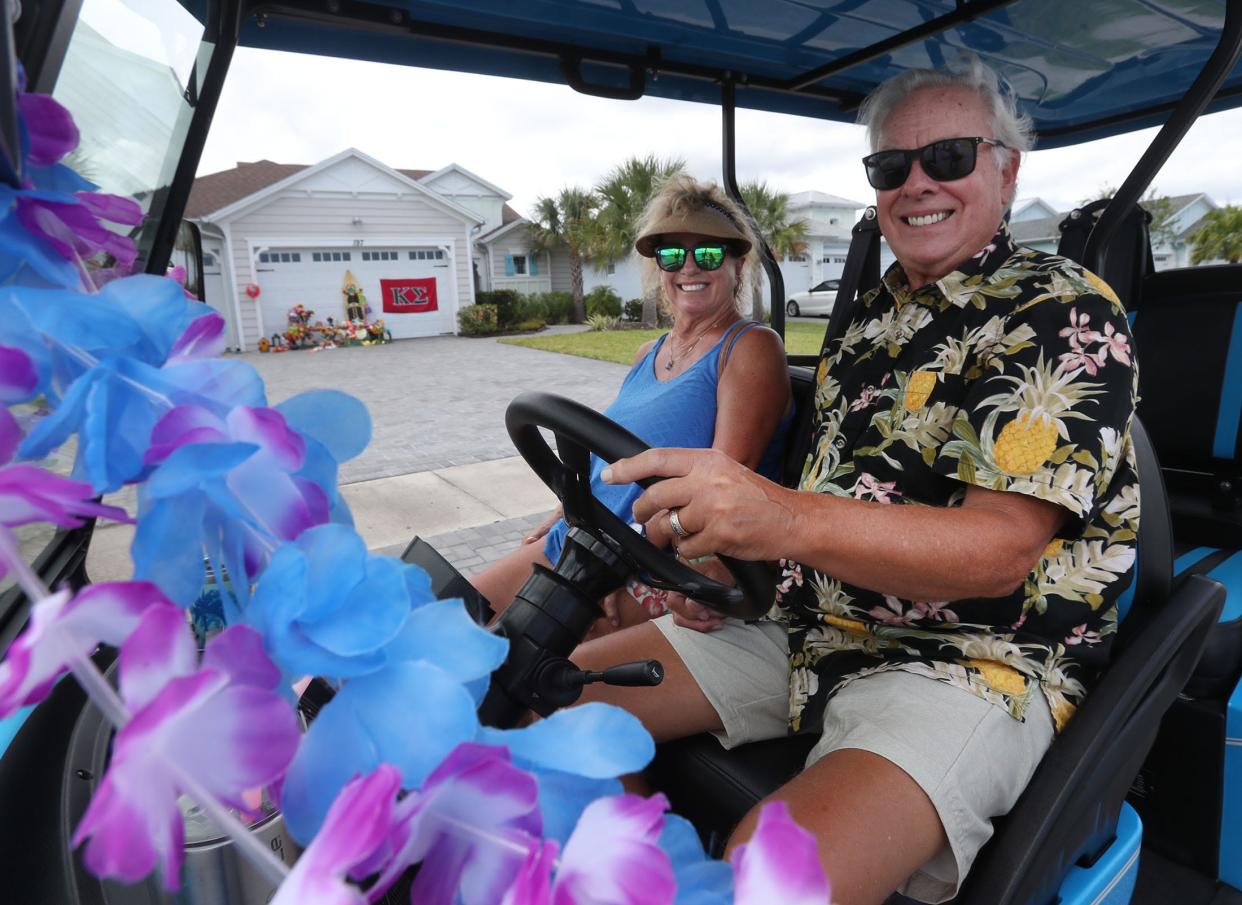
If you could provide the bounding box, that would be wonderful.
[574,60,1139,905]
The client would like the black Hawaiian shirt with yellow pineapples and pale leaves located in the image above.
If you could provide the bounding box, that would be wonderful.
[773,223,1139,732]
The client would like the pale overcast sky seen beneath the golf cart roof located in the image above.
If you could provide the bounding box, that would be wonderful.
[199,48,1242,215]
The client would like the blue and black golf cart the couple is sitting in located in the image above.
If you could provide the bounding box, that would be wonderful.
[0,0,1242,905]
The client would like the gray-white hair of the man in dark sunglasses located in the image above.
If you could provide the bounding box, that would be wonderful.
[858,53,1035,154]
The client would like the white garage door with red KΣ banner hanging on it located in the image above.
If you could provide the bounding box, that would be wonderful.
[256,247,457,339]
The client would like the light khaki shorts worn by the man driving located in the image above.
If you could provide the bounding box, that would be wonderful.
[655,616,1052,903]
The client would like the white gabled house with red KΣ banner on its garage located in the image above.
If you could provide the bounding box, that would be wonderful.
[186,148,534,350]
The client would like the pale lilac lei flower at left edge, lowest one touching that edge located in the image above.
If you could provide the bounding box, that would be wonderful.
[0,581,168,718]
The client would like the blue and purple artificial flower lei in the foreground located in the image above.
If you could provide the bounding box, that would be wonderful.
[0,81,828,905]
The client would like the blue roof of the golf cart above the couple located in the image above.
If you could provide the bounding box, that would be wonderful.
[221,0,1242,148]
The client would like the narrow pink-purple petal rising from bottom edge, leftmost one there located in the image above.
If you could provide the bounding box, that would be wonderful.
[272,763,401,905]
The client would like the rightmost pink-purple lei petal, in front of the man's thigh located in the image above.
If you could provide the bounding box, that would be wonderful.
[733,799,832,905]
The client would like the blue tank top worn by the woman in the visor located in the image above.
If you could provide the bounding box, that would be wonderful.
[544,322,792,562]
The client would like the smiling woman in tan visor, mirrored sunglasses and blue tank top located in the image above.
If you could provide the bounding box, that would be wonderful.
[471,174,792,632]
